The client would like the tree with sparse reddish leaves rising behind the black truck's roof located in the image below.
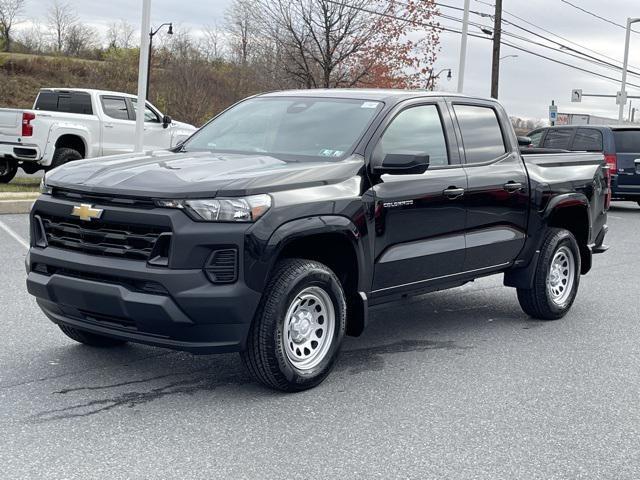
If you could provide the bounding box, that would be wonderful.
[250,0,439,88]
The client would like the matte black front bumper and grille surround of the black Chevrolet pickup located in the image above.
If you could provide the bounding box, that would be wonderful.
[27,196,261,354]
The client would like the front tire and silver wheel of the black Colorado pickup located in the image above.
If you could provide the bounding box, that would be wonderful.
[241,259,347,392]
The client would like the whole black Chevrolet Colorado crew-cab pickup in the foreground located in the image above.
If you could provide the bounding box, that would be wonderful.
[27,90,610,391]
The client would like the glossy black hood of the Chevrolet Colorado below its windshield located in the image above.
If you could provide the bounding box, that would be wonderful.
[46,150,364,198]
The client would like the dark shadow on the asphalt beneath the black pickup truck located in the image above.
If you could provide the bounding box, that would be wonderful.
[28,286,544,423]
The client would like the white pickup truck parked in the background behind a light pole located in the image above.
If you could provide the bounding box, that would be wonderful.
[0,88,196,183]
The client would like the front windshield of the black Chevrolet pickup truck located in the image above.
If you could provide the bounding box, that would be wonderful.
[183,97,382,161]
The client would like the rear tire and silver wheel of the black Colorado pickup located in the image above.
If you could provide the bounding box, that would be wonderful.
[518,228,580,320]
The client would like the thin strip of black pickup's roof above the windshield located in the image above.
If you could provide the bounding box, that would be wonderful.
[259,88,490,102]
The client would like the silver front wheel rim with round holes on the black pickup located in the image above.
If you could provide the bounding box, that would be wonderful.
[284,287,336,370]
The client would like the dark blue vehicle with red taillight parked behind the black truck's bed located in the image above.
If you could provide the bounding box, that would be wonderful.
[529,125,640,205]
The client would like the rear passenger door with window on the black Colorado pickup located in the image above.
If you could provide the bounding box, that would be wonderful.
[452,101,529,272]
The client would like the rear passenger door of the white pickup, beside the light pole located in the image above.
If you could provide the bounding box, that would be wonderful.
[100,95,135,155]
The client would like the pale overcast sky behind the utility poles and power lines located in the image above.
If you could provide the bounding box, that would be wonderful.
[26,0,640,122]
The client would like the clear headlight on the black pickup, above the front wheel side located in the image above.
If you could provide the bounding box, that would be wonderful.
[156,195,271,222]
